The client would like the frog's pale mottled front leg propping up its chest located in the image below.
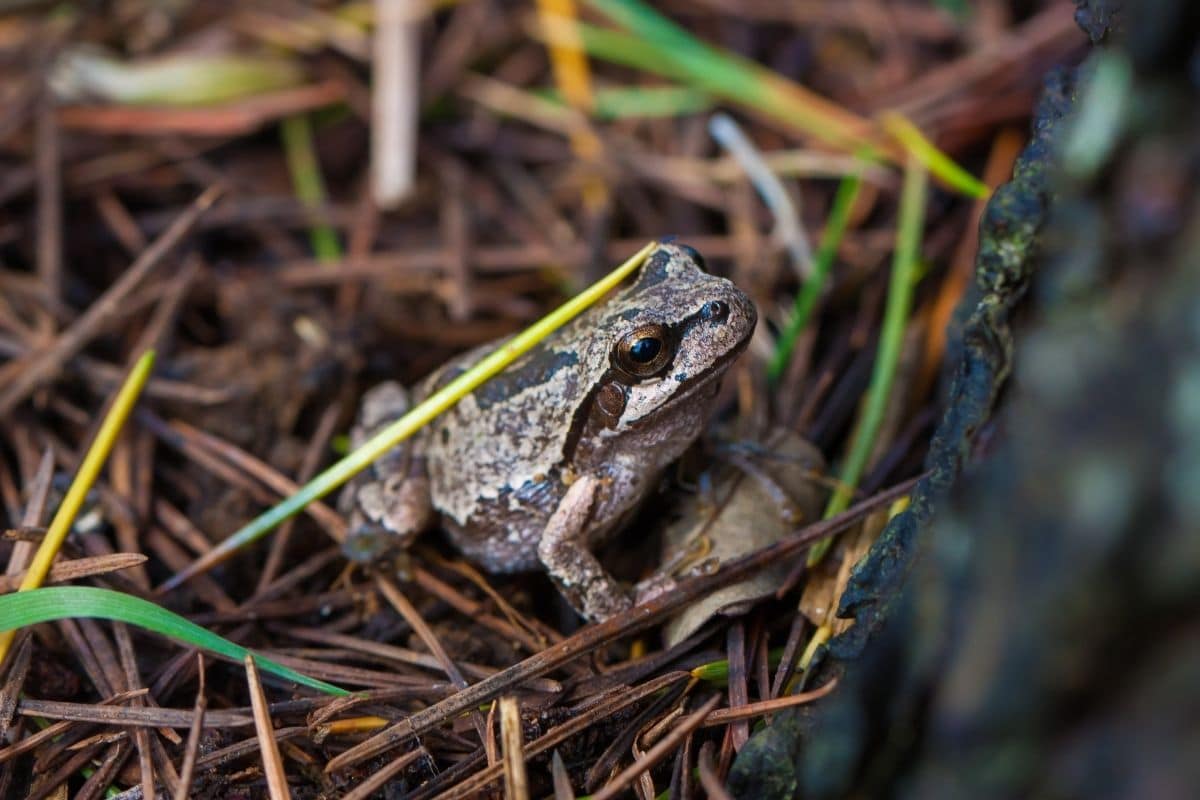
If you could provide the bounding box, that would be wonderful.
[538,475,632,621]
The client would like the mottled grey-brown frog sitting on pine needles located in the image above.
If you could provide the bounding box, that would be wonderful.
[338,240,757,621]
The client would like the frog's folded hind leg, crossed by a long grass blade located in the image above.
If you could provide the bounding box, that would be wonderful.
[338,383,434,563]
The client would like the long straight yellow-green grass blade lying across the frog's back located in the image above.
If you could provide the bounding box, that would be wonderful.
[158,242,658,593]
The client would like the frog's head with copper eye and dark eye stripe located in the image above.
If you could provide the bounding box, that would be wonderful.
[593,243,757,432]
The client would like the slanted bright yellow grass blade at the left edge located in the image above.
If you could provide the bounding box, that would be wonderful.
[0,350,155,663]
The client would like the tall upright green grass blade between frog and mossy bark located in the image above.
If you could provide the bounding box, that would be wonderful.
[808,155,929,566]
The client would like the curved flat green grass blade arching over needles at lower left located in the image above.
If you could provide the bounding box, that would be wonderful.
[0,587,349,696]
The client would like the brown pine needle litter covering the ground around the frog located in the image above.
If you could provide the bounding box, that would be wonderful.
[0,0,1080,800]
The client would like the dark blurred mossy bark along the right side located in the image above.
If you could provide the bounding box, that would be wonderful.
[731,0,1200,798]
